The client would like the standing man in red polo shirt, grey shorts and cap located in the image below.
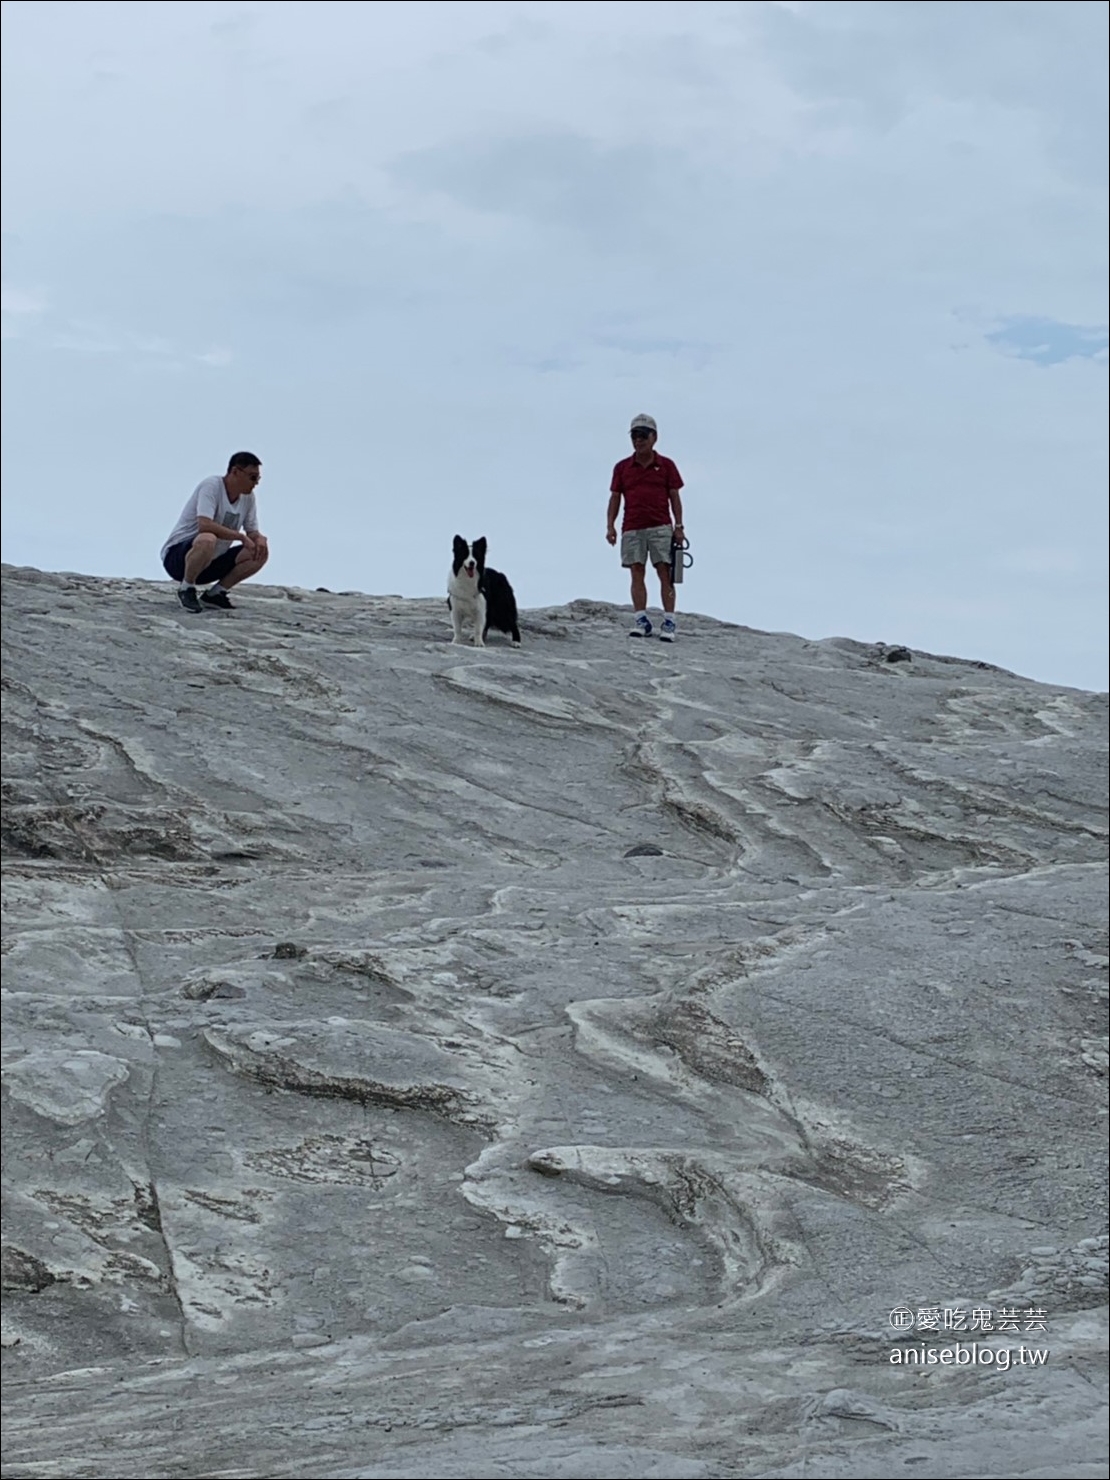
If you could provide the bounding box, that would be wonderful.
[605,411,685,642]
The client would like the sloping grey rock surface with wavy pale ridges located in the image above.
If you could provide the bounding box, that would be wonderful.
[3,568,1107,1480]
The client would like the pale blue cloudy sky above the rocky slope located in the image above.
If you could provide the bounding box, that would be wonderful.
[3,0,1110,690]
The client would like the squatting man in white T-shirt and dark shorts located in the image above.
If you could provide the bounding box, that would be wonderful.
[161,453,269,611]
